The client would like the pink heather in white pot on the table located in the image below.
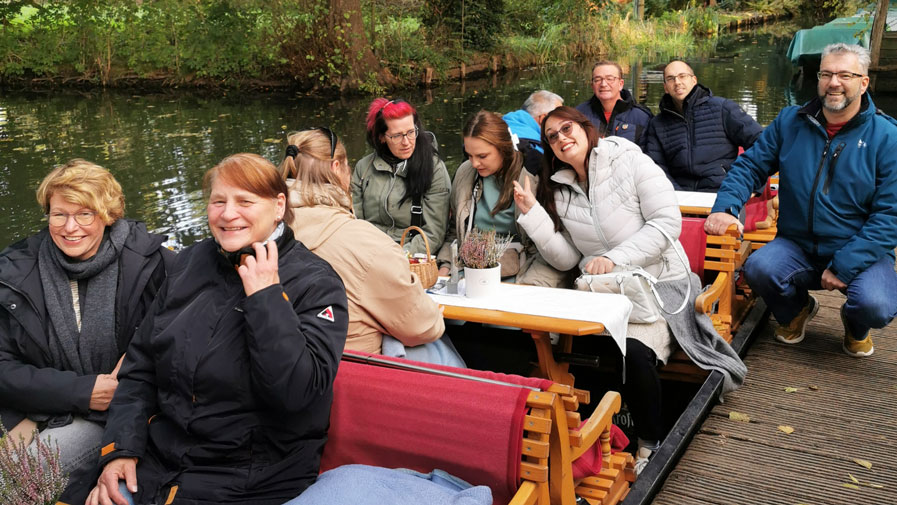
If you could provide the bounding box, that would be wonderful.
[458,228,511,298]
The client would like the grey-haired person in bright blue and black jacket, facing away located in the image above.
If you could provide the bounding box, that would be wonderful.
[502,89,564,175]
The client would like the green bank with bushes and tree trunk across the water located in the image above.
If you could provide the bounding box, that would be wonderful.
[0,0,859,92]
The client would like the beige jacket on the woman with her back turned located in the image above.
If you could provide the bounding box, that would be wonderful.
[289,191,445,353]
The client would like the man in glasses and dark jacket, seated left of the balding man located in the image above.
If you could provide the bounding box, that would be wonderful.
[576,60,652,148]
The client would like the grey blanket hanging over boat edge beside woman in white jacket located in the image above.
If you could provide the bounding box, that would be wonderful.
[657,272,747,394]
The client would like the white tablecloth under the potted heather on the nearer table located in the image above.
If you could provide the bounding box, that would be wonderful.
[429,280,632,354]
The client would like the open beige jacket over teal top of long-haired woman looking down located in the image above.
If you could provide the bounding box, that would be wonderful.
[437,156,572,288]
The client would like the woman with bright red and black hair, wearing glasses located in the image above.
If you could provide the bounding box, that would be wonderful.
[352,98,451,254]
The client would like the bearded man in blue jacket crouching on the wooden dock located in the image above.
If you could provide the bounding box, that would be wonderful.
[705,43,897,357]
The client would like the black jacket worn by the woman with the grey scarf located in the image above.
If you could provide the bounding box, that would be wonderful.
[0,221,174,428]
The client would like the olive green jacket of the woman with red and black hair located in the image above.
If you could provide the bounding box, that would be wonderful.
[352,153,451,255]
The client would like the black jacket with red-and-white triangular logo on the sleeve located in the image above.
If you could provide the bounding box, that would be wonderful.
[100,232,348,505]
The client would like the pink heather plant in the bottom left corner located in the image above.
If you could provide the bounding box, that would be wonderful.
[0,424,68,505]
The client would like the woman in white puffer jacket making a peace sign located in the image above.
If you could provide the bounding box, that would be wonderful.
[514,107,746,472]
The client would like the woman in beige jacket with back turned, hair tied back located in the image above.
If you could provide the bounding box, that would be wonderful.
[280,128,464,366]
